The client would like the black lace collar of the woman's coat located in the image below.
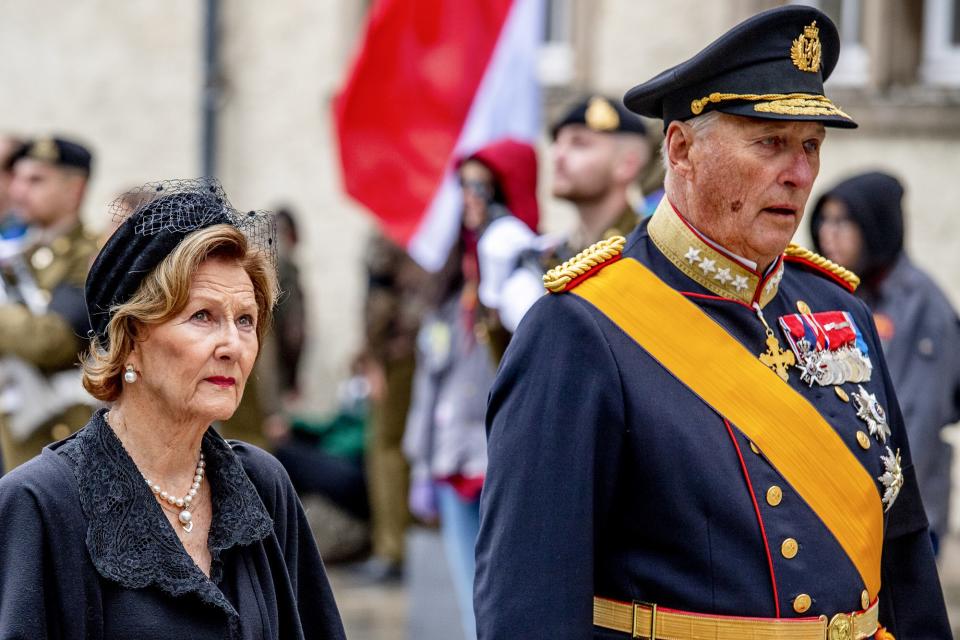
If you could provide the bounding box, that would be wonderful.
[61,409,273,626]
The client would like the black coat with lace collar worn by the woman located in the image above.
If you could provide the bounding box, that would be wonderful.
[0,411,345,640]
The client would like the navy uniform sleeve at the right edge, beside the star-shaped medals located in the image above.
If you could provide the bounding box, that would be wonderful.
[863,300,952,640]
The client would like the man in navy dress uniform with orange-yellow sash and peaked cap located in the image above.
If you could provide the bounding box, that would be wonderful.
[475,5,950,640]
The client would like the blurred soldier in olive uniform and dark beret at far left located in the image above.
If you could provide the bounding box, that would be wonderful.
[0,138,97,470]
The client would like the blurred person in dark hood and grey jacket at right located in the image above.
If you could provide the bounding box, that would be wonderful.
[810,172,960,550]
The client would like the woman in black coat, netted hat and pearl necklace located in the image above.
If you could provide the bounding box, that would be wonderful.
[0,180,344,640]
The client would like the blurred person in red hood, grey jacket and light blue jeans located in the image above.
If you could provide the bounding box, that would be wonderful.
[404,140,539,640]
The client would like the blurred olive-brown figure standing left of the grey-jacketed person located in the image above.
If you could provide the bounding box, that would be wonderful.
[359,231,426,583]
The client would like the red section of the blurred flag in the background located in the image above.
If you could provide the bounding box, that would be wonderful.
[335,0,512,246]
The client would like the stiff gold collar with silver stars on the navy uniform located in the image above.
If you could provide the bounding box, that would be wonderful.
[647,197,783,308]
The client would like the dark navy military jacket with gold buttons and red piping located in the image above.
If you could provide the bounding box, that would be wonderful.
[475,208,950,640]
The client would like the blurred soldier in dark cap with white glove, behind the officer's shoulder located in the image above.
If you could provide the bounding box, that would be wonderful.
[480,95,663,332]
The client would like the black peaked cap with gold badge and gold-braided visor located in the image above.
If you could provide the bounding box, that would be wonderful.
[623,5,857,131]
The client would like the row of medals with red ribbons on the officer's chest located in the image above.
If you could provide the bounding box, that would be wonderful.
[779,311,873,386]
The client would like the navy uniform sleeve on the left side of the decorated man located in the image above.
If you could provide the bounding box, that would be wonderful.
[474,295,624,640]
